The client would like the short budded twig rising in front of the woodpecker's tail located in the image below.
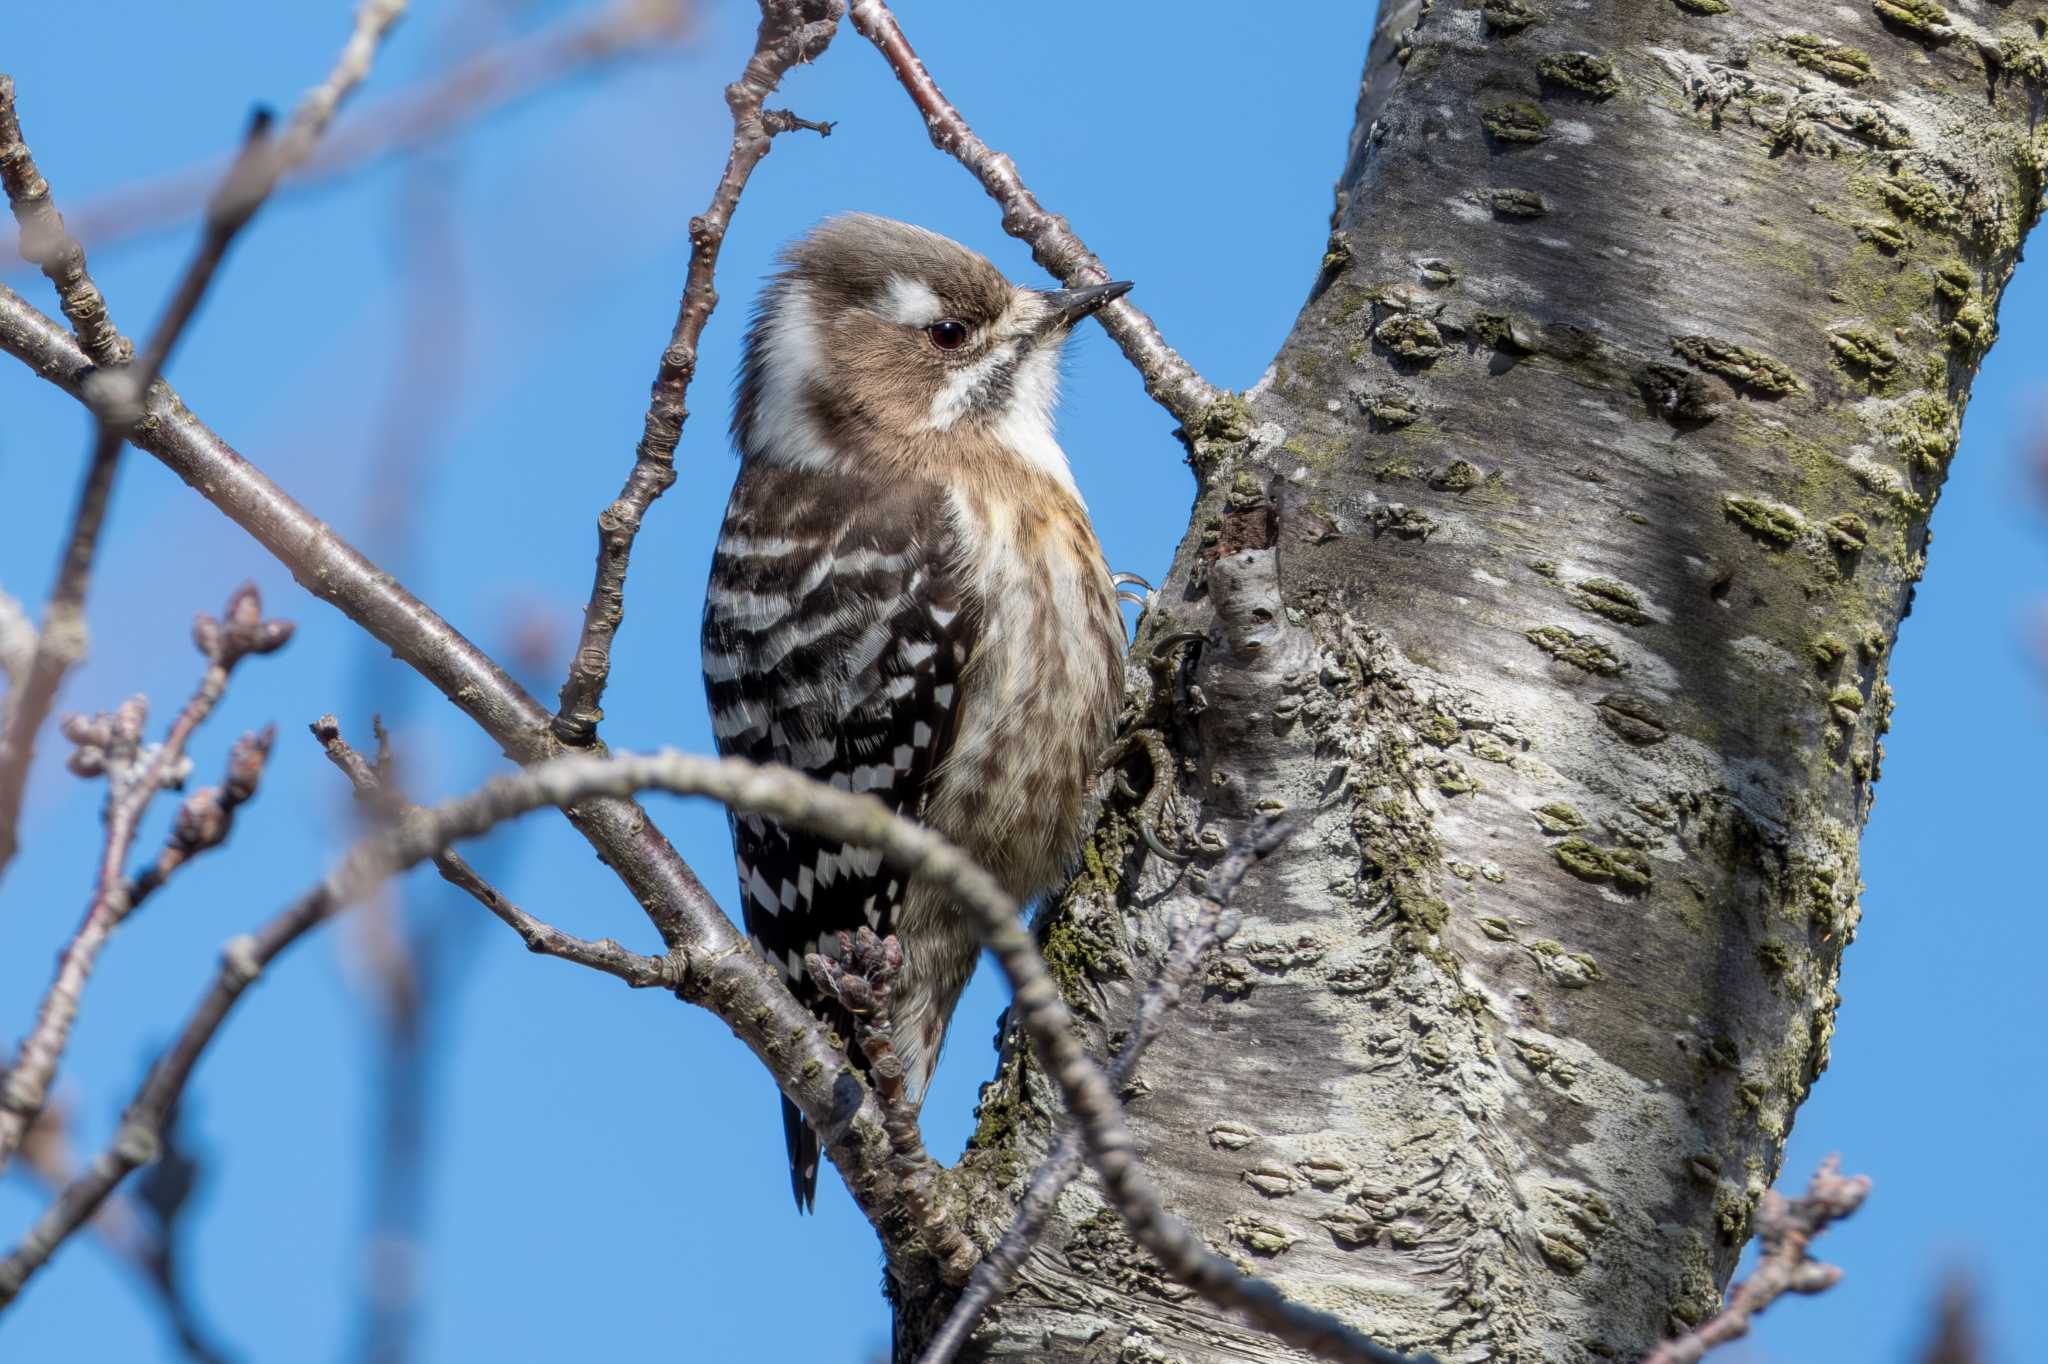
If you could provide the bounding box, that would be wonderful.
[803,926,979,1286]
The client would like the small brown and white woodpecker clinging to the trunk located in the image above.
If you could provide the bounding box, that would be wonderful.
[702,213,1130,1210]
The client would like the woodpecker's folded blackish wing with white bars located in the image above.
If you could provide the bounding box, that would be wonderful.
[705,469,973,1001]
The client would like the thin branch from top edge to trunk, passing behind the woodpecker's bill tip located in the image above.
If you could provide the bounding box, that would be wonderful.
[848,0,1219,432]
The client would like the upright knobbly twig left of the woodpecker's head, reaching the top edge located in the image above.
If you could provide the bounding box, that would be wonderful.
[553,0,846,748]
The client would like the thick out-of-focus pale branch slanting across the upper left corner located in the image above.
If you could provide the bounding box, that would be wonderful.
[0,0,692,262]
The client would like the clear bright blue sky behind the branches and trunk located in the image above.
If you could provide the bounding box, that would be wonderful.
[0,0,2048,1364]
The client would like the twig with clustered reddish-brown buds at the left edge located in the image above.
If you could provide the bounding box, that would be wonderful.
[0,584,291,1169]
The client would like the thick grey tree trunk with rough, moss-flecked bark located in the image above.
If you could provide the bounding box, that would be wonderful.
[901,0,2048,1364]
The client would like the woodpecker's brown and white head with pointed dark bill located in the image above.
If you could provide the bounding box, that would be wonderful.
[733,213,1130,467]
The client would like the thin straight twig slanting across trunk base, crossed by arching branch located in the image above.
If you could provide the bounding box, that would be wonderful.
[918,821,1294,1364]
